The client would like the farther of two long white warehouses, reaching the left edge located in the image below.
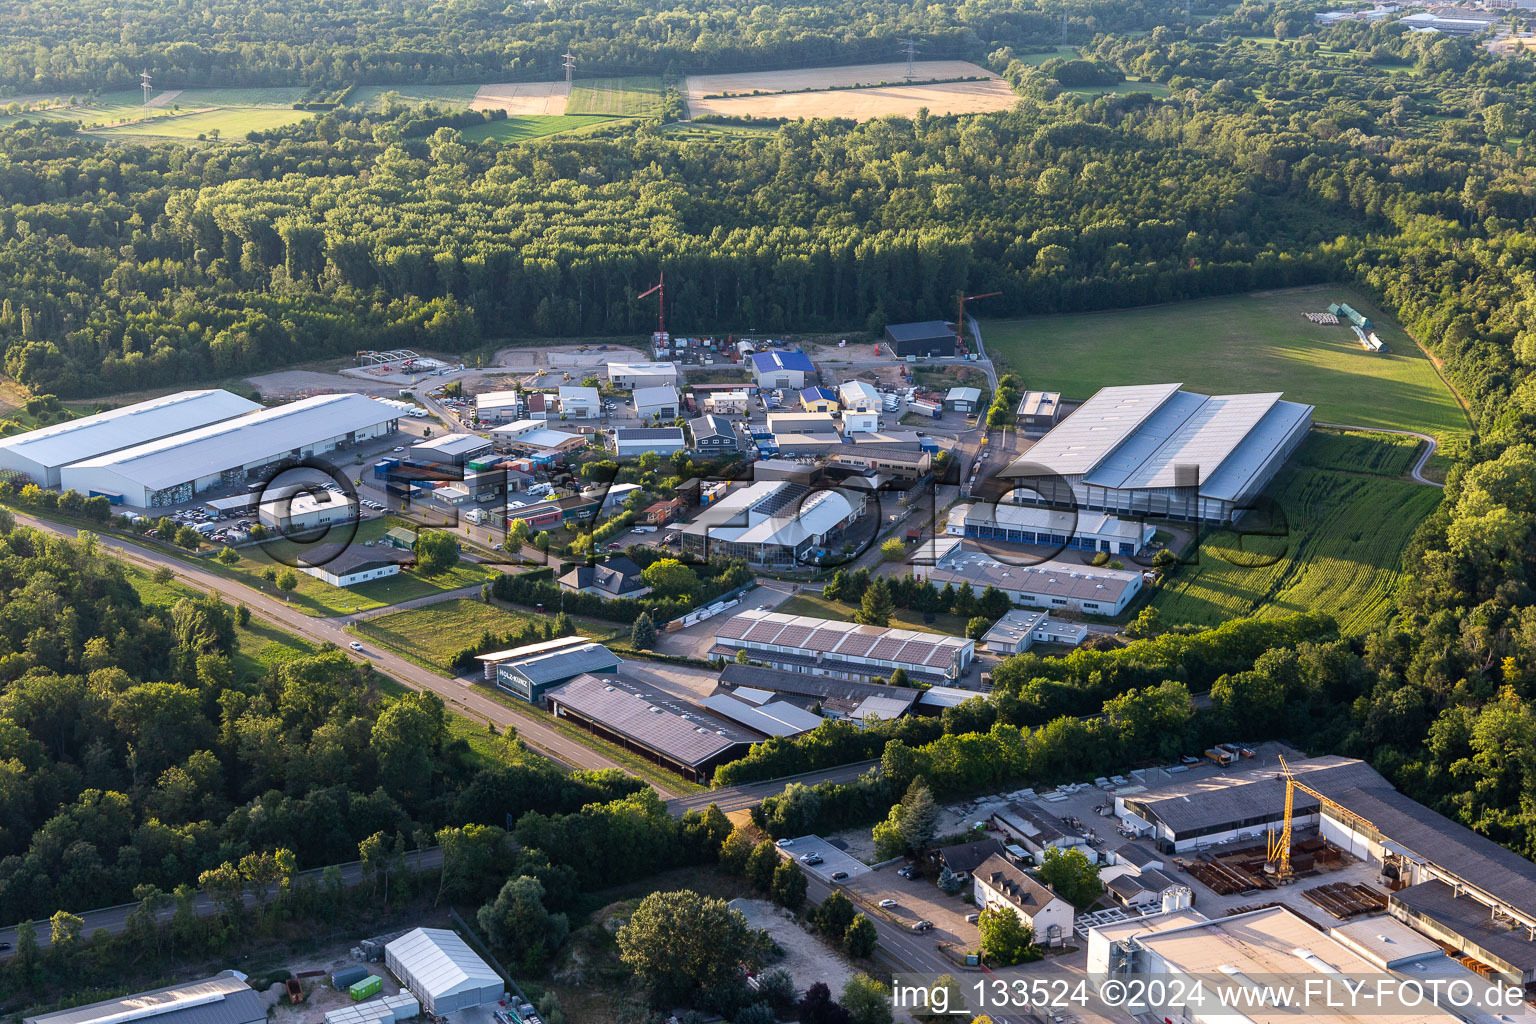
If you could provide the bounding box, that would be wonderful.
[0,390,261,487]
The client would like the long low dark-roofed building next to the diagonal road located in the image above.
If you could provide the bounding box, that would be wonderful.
[544,676,762,781]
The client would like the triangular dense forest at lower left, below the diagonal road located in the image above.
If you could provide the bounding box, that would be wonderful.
[0,513,644,921]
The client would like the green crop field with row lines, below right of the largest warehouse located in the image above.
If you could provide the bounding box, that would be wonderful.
[1150,454,1441,636]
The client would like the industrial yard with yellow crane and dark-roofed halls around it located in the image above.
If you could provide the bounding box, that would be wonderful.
[965,743,1536,993]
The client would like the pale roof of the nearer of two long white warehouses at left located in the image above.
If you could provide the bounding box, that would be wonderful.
[72,395,399,491]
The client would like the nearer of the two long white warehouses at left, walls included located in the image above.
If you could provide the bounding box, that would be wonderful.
[60,395,401,508]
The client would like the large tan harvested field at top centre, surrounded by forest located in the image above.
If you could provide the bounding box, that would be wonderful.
[685,60,1018,121]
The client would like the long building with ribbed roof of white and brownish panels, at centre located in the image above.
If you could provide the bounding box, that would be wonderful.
[710,609,975,683]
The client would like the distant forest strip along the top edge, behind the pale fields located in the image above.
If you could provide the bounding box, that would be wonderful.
[0,0,1198,97]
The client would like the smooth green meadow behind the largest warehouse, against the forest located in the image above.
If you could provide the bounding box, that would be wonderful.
[983,286,1467,439]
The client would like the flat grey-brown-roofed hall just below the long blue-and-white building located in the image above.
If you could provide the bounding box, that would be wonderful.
[912,537,1143,616]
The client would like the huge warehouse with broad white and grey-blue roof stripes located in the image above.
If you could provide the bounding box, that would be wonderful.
[1003,384,1312,522]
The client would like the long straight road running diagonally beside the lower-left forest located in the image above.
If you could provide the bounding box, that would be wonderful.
[7,514,654,798]
